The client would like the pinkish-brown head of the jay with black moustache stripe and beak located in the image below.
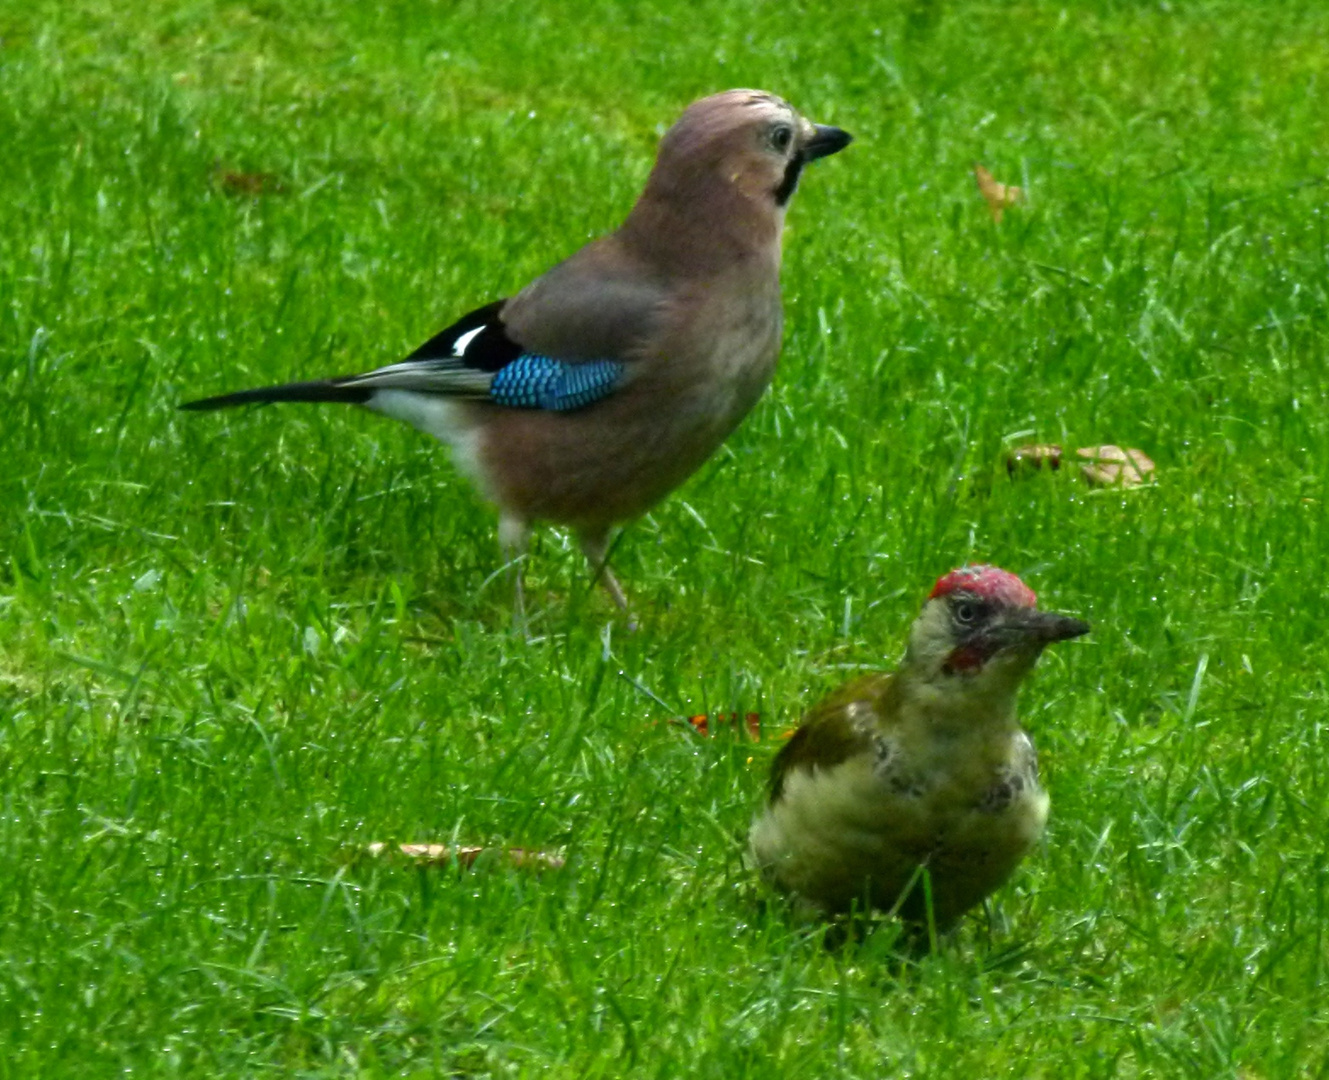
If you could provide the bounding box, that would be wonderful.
[647,90,853,211]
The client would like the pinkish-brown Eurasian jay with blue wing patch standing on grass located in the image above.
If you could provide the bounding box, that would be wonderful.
[182,90,851,624]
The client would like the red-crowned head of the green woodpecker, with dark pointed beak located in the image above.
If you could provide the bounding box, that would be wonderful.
[905,566,1088,692]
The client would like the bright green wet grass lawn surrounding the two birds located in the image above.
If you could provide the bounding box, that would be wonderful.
[0,0,1329,1077]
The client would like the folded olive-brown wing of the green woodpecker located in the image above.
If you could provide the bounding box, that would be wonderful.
[771,675,897,802]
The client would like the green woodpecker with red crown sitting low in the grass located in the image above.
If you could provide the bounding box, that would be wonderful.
[751,566,1088,931]
